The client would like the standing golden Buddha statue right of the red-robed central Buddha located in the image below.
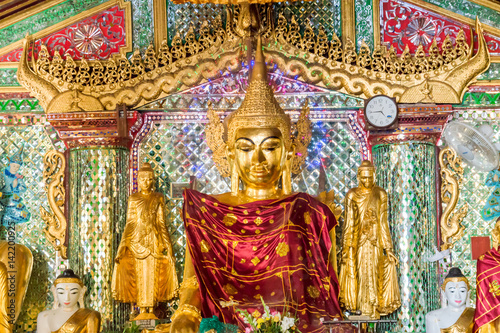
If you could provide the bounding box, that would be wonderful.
[339,161,401,319]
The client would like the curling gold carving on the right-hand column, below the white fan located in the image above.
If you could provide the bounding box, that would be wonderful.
[439,147,469,250]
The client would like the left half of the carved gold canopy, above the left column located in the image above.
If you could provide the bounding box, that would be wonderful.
[18,11,242,113]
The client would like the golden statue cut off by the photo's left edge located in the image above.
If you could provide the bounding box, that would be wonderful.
[0,241,33,332]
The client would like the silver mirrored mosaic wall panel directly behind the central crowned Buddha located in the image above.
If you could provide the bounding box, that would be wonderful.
[139,121,361,278]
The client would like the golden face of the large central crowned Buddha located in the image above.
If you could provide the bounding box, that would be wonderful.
[234,128,286,188]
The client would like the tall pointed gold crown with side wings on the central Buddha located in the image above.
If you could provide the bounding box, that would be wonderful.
[205,36,311,177]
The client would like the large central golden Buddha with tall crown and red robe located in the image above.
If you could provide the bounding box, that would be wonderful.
[171,38,341,333]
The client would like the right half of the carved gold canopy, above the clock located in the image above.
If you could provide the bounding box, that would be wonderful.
[266,14,490,103]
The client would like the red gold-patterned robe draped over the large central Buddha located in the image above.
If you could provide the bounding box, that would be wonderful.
[183,190,341,332]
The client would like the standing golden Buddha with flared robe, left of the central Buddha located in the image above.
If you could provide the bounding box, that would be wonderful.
[111,163,178,320]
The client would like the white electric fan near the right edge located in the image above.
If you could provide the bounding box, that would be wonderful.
[444,121,500,172]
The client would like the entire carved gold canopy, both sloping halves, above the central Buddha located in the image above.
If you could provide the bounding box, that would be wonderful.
[18,6,490,113]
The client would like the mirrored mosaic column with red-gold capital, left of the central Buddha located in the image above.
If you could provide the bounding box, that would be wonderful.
[47,110,135,331]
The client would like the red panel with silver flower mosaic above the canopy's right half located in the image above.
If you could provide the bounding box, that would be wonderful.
[380,0,500,56]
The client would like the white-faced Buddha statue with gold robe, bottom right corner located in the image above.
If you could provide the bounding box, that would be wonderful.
[425,267,475,333]
